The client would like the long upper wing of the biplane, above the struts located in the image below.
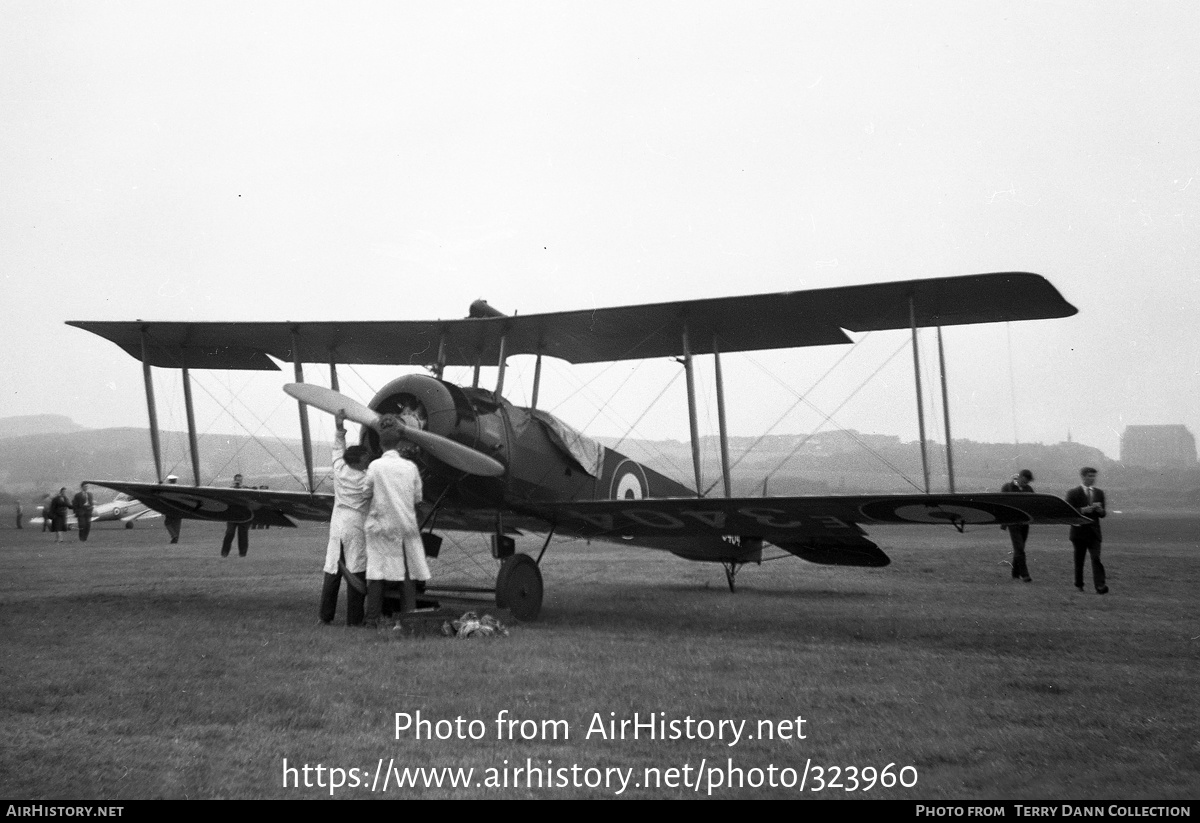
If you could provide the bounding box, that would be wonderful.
[68,271,1076,370]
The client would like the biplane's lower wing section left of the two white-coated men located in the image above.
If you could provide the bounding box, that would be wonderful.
[88,480,334,525]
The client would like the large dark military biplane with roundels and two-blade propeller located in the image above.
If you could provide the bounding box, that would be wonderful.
[70,272,1094,619]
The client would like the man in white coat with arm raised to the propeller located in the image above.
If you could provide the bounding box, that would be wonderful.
[320,412,371,626]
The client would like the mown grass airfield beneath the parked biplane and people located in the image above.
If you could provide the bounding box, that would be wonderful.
[0,515,1200,800]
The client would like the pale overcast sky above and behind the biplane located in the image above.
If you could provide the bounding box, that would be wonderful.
[0,0,1200,477]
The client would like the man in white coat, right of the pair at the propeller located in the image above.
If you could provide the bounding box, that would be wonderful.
[365,415,430,625]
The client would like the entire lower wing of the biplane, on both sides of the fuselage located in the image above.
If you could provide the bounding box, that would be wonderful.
[89,481,1087,566]
